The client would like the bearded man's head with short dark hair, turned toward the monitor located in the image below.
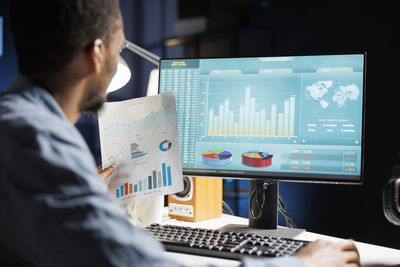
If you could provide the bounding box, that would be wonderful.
[10,0,123,115]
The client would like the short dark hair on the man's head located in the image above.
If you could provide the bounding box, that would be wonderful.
[10,0,121,75]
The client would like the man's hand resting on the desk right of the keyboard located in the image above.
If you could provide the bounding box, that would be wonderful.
[295,240,360,267]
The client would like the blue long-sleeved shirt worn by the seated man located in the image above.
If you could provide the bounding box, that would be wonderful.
[0,74,304,267]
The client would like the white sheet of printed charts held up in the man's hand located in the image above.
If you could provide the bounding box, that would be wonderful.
[99,92,183,204]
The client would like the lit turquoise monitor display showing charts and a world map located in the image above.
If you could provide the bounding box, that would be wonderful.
[159,53,365,183]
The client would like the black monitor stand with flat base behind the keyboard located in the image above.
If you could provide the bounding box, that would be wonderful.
[220,180,304,238]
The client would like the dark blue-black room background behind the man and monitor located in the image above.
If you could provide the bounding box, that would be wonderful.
[0,0,400,249]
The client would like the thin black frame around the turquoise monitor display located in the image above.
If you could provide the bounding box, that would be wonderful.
[158,51,367,185]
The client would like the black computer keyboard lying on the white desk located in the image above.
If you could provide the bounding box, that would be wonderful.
[146,224,309,260]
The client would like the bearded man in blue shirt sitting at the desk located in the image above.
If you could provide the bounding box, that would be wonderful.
[0,0,359,266]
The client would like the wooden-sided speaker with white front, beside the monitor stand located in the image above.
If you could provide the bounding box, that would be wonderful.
[168,176,222,222]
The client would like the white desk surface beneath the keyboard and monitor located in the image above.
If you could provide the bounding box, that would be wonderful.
[157,214,400,267]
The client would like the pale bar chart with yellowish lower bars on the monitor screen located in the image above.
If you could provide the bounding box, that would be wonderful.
[206,86,296,137]
